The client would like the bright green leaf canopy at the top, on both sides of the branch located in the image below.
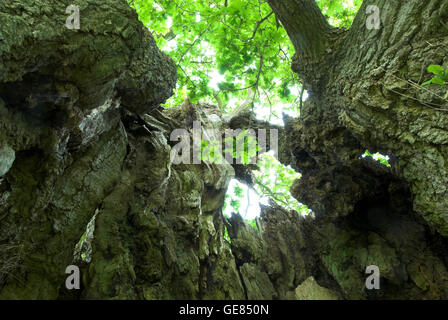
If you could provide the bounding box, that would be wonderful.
[130,0,361,112]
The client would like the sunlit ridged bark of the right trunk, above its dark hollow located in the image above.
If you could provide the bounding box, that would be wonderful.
[272,1,448,232]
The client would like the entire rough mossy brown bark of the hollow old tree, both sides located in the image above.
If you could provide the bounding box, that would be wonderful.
[0,0,448,299]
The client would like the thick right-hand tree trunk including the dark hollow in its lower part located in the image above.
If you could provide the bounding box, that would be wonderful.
[269,0,448,298]
